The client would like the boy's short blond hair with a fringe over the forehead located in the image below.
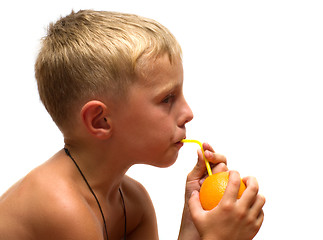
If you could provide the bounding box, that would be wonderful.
[35,10,181,127]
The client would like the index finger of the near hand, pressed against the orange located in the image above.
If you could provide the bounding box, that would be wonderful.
[219,171,241,205]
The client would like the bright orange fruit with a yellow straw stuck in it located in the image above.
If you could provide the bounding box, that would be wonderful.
[200,172,246,210]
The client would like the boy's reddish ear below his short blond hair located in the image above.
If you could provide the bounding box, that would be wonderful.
[81,100,112,140]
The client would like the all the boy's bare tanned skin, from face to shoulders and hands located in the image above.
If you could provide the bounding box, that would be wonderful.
[0,55,265,240]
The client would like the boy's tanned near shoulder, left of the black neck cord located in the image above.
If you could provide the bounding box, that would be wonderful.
[0,159,103,240]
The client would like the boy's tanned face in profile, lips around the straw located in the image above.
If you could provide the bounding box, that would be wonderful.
[113,55,193,167]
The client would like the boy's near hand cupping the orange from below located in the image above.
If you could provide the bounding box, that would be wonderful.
[189,171,265,240]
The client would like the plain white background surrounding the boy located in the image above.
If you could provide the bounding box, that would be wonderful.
[0,0,323,240]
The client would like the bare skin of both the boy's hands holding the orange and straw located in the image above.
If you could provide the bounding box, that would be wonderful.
[179,143,265,240]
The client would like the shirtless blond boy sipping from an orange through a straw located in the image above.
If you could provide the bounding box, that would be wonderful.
[0,11,265,240]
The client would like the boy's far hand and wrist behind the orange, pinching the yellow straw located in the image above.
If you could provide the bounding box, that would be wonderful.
[178,143,228,240]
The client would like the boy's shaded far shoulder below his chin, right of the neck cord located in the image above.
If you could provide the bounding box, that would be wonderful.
[121,176,158,239]
